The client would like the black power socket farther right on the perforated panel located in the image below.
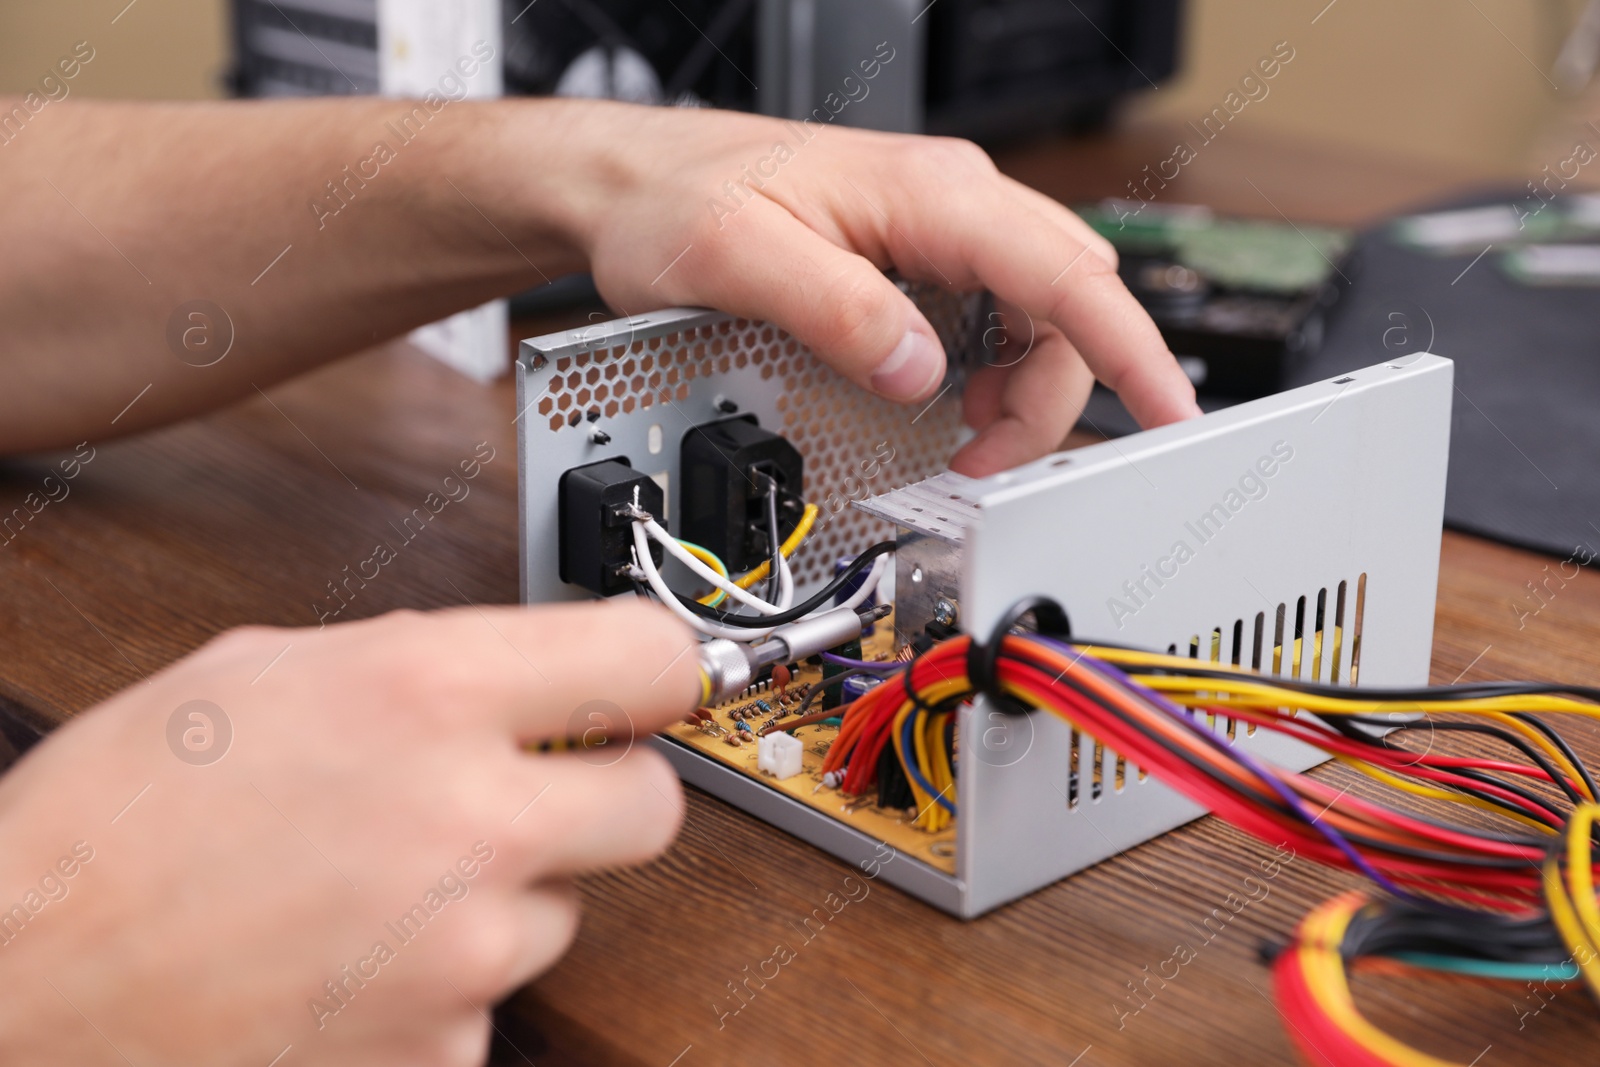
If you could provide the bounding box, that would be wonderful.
[678,414,805,571]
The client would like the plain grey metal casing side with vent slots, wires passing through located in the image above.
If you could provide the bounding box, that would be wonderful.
[862,355,1453,915]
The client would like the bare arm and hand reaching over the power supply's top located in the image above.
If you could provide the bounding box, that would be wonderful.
[0,99,1197,474]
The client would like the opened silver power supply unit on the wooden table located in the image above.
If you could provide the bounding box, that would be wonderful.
[517,290,1453,917]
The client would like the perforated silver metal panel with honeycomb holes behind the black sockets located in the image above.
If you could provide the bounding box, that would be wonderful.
[517,285,986,603]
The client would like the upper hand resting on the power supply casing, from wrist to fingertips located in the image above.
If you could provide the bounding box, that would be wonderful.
[540,106,1200,475]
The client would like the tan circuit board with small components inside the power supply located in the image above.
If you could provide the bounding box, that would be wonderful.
[666,616,955,875]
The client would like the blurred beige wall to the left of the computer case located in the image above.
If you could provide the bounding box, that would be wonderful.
[0,0,227,99]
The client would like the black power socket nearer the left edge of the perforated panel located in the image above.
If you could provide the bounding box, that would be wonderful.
[557,456,666,597]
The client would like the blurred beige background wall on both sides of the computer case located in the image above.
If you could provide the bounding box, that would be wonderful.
[0,0,1584,168]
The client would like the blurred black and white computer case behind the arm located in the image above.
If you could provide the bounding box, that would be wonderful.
[230,0,1181,378]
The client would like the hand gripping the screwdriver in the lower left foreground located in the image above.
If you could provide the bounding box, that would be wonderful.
[0,603,698,1067]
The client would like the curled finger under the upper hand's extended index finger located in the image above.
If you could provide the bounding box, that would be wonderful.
[950,308,1094,477]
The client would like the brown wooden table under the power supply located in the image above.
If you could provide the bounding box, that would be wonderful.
[0,120,1600,1067]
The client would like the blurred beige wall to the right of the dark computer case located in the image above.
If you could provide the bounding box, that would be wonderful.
[1133,0,1584,166]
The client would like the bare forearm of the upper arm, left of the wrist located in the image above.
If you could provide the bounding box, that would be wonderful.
[0,99,592,453]
